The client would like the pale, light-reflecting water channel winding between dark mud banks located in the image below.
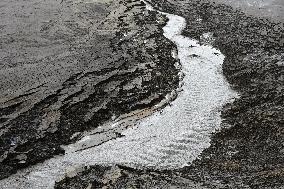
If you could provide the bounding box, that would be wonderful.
[0,1,237,189]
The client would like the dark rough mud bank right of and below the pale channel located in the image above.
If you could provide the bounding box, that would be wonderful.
[57,0,284,189]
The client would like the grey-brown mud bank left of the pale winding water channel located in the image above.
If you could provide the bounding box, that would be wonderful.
[0,0,179,178]
